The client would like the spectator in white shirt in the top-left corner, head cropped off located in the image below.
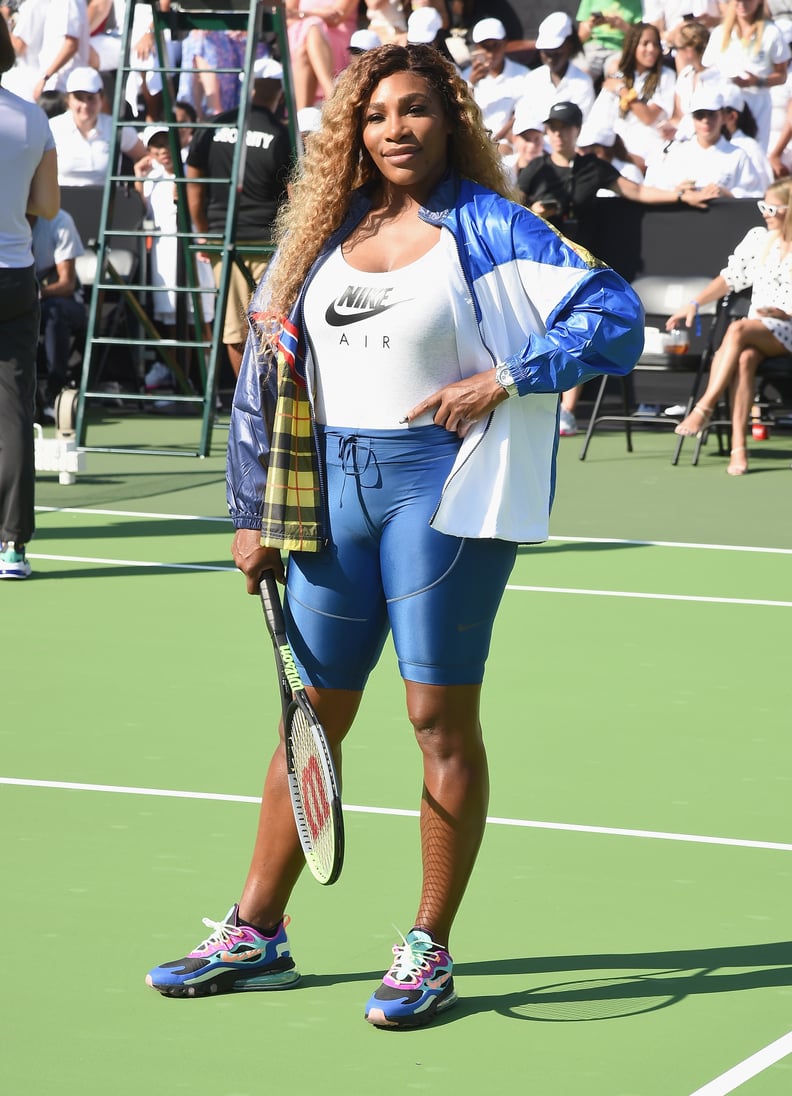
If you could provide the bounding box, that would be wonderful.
[3,0,91,103]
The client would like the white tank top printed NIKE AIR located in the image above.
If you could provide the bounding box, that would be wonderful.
[303,244,461,430]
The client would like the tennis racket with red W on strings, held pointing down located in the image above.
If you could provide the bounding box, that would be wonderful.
[259,571,344,886]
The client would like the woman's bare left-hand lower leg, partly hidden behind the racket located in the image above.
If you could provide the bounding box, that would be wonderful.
[239,688,363,929]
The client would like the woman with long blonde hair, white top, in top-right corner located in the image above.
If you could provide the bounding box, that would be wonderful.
[702,0,791,152]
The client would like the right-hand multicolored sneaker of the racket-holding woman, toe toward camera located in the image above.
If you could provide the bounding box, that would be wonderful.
[366,928,457,1028]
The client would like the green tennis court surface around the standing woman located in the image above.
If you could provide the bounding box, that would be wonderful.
[0,415,792,1096]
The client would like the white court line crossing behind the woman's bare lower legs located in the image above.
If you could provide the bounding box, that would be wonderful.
[0,776,792,853]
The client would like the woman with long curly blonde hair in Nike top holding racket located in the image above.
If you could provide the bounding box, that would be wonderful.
[147,45,642,1028]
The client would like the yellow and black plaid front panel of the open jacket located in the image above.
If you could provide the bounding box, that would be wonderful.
[261,353,323,551]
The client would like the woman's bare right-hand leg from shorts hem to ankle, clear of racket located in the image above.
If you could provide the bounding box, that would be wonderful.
[405,682,490,947]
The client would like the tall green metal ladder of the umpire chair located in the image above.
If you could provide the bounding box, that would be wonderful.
[74,0,300,457]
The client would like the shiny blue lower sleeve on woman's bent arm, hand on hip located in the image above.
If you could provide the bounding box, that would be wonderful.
[505,266,644,396]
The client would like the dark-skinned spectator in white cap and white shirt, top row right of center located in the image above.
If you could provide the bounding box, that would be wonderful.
[523,11,594,129]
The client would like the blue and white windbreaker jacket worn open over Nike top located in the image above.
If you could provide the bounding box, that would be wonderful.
[228,175,643,549]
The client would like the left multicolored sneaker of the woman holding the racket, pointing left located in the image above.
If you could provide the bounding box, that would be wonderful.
[146,905,300,997]
